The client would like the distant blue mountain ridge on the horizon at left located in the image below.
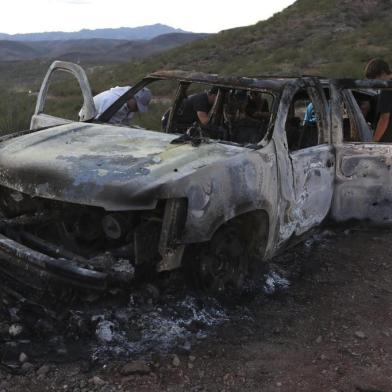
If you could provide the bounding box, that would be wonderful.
[0,23,185,41]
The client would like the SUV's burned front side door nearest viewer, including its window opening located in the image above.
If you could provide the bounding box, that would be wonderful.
[276,79,335,247]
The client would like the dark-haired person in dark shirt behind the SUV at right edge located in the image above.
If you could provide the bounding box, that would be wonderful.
[365,59,392,143]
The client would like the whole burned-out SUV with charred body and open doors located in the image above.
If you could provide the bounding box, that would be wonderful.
[0,62,392,290]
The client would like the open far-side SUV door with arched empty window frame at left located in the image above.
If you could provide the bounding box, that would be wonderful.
[30,61,96,130]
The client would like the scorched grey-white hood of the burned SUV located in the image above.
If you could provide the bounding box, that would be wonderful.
[0,123,247,210]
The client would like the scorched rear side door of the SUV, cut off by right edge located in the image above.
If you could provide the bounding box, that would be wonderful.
[331,81,392,224]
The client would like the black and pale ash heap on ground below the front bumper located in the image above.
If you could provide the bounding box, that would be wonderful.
[0,274,230,374]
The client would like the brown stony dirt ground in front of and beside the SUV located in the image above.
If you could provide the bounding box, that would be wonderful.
[0,224,392,392]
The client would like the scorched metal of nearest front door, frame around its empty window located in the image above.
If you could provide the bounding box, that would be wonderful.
[271,79,335,254]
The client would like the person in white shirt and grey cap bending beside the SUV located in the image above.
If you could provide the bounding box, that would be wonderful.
[93,86,152,125]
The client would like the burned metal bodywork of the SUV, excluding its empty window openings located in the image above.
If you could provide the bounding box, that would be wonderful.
[0,62,392,287]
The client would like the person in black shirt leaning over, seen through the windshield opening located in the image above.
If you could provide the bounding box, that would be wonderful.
[176,87,218,125]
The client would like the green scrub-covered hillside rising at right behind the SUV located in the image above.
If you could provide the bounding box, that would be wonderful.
[92,0,392,87]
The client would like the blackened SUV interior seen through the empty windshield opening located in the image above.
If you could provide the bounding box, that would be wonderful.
[130,80,274,146]
